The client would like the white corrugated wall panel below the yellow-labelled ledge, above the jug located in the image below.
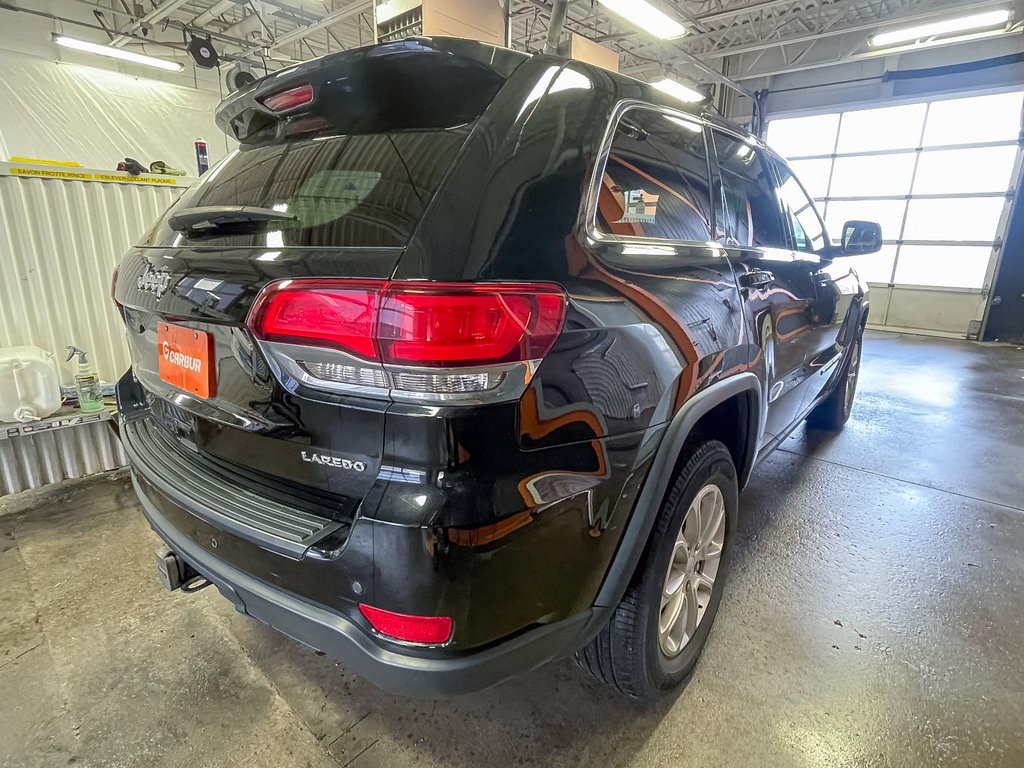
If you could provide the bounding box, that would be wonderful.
[0,176,182,384]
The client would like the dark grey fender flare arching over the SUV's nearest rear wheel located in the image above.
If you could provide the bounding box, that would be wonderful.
[594,372,763,607]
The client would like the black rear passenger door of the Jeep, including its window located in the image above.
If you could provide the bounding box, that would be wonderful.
[712,128,815,442]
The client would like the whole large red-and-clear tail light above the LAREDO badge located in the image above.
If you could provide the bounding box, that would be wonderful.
[248,280,566,399]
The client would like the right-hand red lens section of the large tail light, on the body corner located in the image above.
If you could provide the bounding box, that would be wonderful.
[377,283,565,368]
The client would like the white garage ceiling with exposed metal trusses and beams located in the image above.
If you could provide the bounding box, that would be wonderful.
[75,0,1020,80]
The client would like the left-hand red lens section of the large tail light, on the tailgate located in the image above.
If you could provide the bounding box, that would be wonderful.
[248,280,384,359]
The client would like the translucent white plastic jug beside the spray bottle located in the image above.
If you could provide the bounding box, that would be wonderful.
[0,347,60,423]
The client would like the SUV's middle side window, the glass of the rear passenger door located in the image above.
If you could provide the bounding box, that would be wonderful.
[712,130,790,248]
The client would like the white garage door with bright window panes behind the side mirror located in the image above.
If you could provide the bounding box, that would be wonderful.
[767,91,1024,336]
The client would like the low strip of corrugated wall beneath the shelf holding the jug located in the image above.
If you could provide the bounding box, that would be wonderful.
[0,422,128,497]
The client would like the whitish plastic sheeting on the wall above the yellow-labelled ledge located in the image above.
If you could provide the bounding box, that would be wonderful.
[0,51,233,175]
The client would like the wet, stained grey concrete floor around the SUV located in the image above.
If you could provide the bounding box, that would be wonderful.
[0,334,1024,768]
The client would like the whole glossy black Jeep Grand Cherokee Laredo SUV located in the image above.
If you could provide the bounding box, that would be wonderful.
[114,38,881,697]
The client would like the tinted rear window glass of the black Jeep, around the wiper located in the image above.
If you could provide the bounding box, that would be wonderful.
[142,125,470,248]
